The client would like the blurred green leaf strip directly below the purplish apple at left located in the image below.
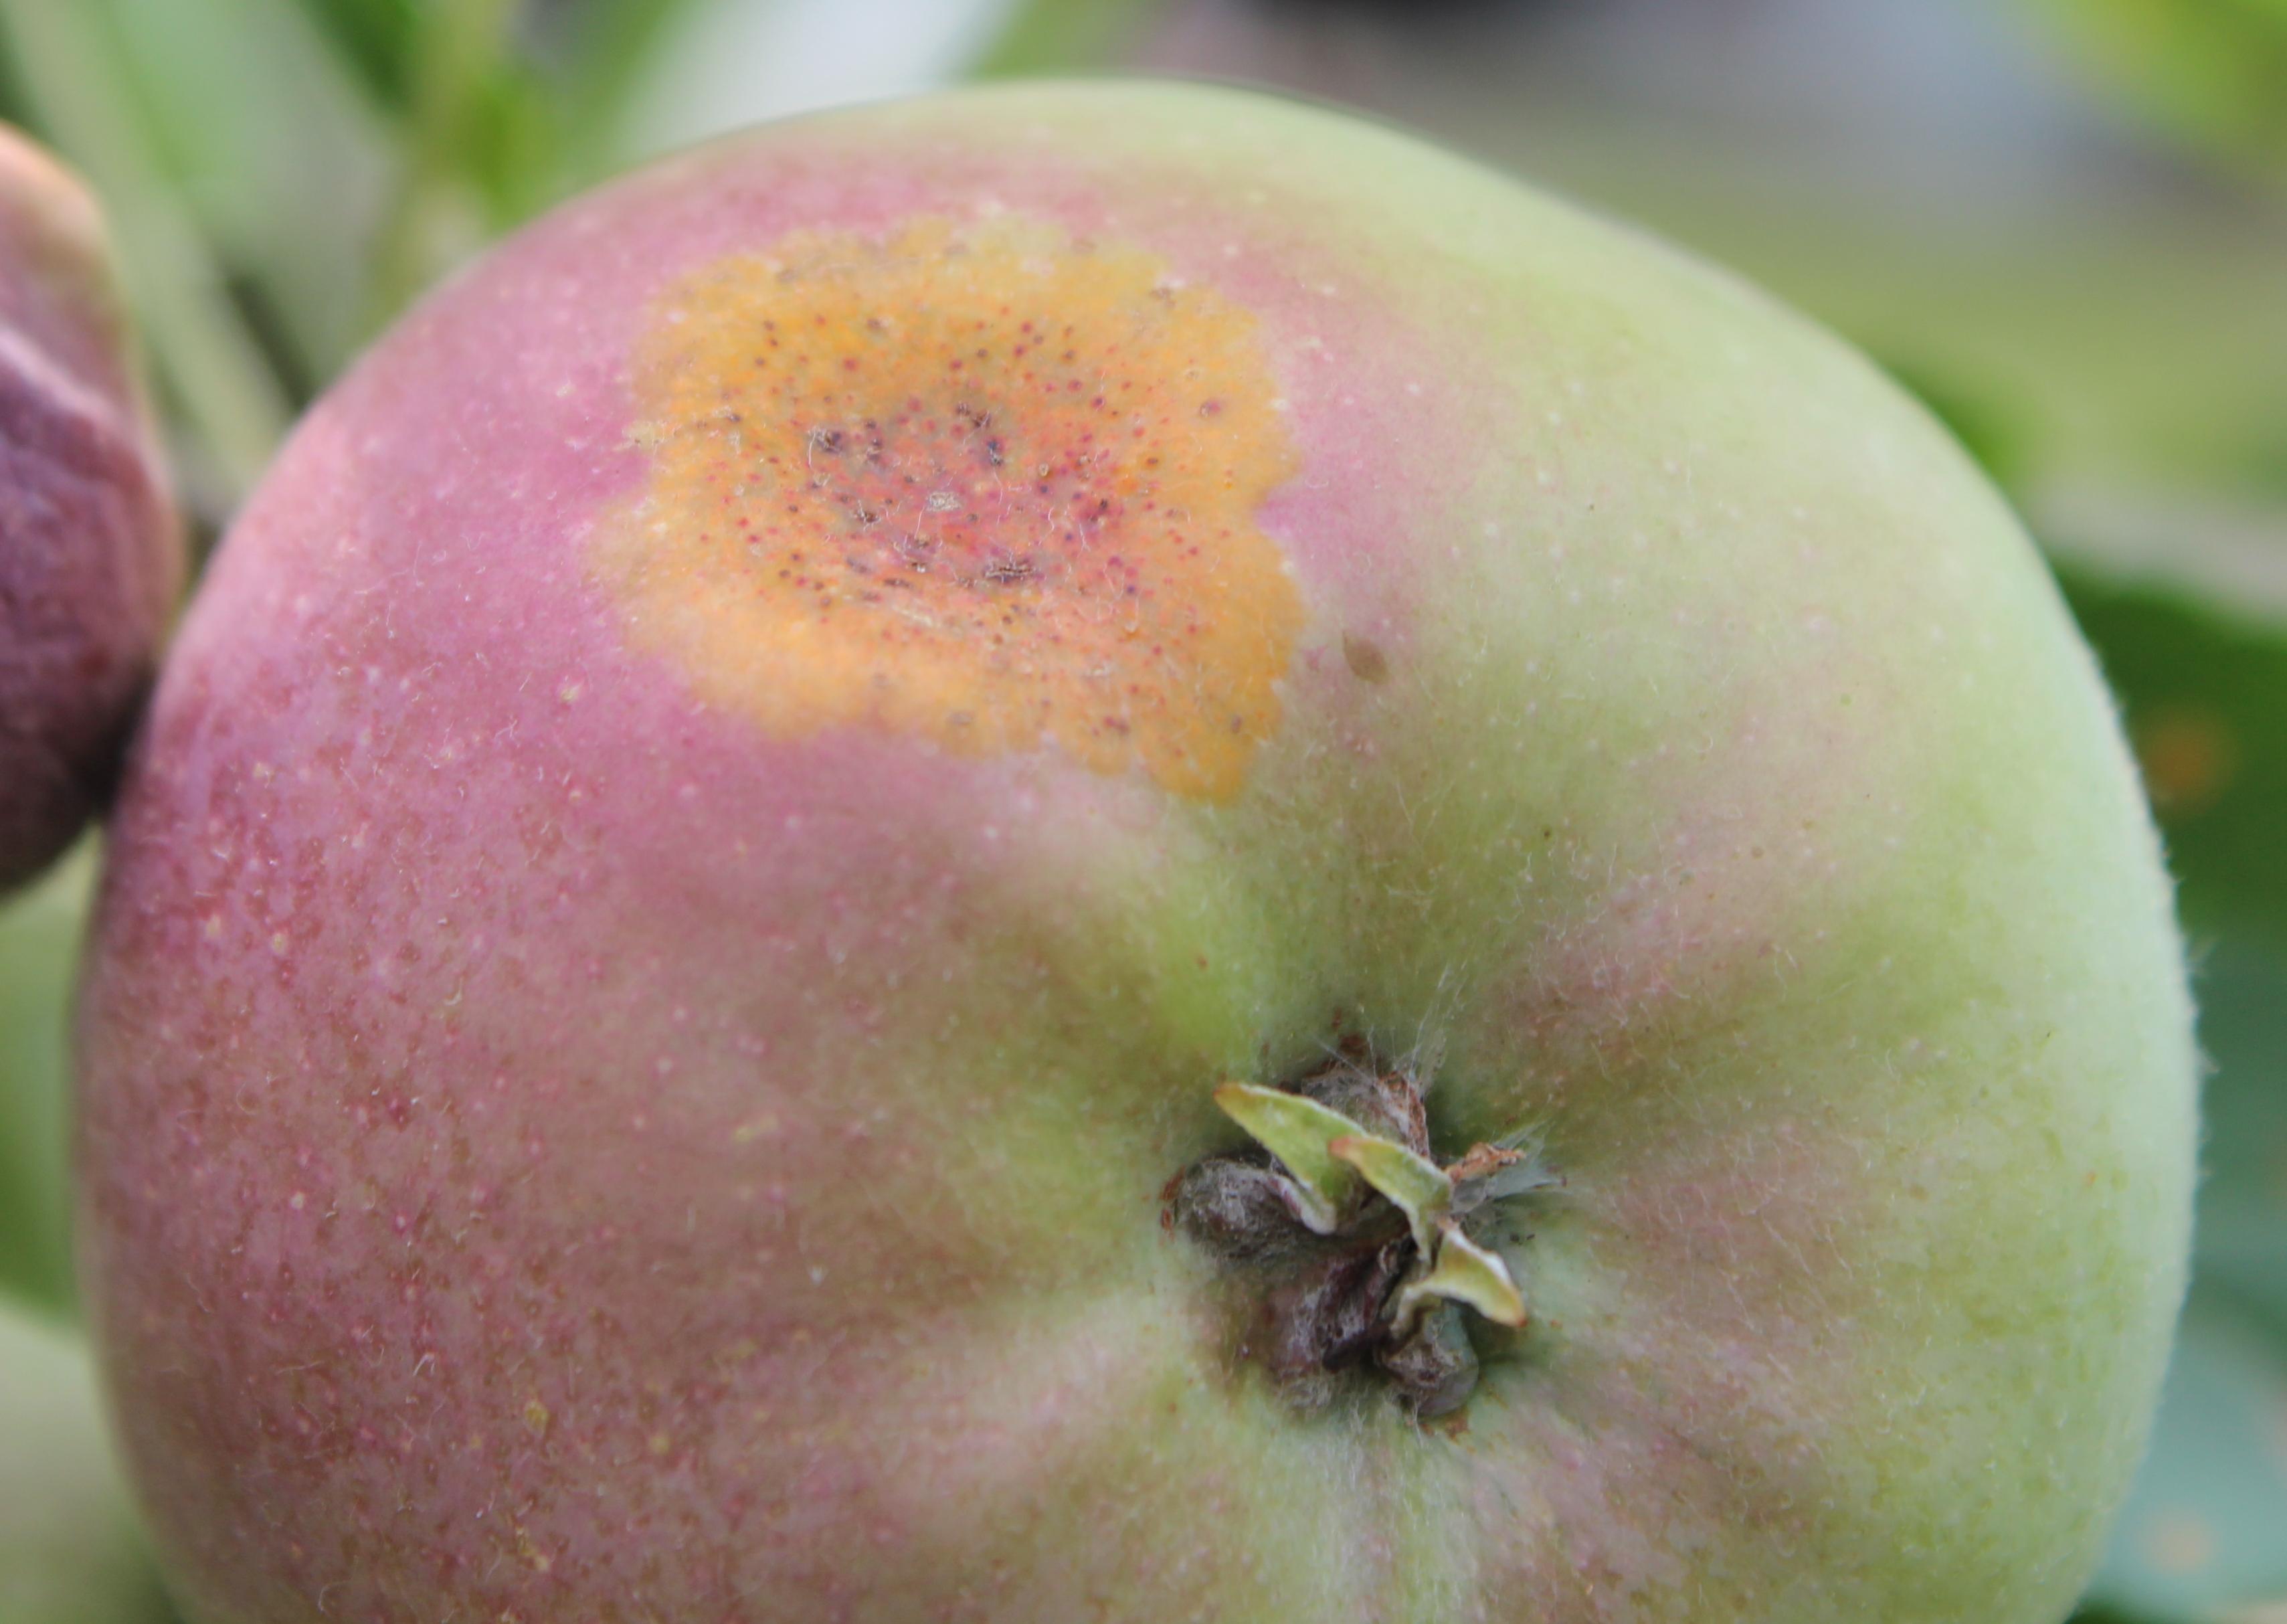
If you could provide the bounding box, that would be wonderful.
[0,842,96,1317]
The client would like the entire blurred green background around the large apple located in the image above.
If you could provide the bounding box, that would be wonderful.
[0,0,2287,1624]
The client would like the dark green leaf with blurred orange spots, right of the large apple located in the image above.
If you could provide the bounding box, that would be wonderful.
[2061,549,2287,1624]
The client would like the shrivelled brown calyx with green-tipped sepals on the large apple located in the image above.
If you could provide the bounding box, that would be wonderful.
[1169,1057,1560,1418]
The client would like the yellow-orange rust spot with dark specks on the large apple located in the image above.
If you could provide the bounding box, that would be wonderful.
[600,219,1301,798]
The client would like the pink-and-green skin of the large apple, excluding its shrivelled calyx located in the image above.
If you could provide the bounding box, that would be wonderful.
[80,84,2195,1624]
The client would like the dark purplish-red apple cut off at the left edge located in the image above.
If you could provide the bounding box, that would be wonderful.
[0,126,183,892]
